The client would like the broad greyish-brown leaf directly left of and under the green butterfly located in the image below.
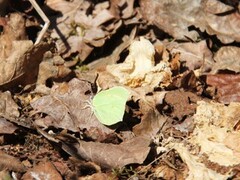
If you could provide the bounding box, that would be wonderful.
[31,78,113,139]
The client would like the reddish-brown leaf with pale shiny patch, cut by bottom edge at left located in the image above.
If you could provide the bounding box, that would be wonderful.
[22,161,62,180]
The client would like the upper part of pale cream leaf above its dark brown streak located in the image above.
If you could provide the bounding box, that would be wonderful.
[190,101,240,166]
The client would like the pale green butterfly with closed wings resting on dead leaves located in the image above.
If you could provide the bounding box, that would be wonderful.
[92,86,130,126]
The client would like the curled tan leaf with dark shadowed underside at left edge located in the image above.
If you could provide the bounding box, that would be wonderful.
[0,41,50,89]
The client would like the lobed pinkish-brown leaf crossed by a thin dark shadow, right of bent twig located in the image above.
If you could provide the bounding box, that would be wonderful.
[46,0,119,61]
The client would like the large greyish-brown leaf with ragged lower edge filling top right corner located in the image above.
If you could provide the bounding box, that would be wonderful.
[140,0,240,43]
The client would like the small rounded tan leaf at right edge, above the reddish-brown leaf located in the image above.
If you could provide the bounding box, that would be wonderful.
[211,46,240,74]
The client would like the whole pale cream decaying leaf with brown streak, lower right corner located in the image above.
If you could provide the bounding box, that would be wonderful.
[167,101,240,179]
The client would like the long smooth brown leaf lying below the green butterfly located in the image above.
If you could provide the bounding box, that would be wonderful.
[75,136,150,168]
